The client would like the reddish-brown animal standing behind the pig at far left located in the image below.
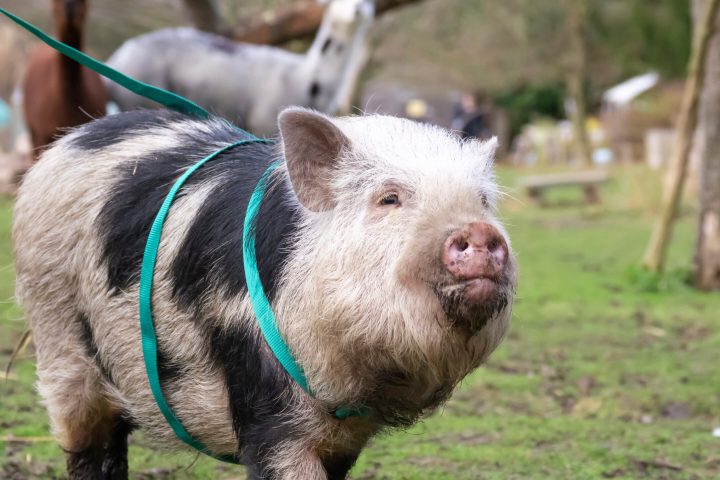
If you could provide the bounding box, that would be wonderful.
[23,0,107,159]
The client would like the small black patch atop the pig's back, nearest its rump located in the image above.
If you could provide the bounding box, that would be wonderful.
[70,110,187,150]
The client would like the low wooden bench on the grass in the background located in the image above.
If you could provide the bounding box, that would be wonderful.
[519,170,610,204]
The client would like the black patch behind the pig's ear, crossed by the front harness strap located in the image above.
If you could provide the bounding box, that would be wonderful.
[172,151,300,309]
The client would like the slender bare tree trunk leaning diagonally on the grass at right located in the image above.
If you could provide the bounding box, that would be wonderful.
[643,0,720,272]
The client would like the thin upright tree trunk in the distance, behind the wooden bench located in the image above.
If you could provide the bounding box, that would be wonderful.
[567,0,592,166]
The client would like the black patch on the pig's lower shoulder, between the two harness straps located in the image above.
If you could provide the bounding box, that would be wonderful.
[206,321,298,470]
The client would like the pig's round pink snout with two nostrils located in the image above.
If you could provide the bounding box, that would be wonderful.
[442,222,508,281]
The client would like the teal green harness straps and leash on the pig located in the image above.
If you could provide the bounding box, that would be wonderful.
[0,7,370,464]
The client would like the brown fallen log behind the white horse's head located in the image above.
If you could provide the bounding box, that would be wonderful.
[229,0,421,45]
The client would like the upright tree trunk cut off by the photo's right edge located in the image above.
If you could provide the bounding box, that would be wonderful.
[693,0,720,290]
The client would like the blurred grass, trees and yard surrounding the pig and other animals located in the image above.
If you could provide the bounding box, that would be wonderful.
[0,0,720,479]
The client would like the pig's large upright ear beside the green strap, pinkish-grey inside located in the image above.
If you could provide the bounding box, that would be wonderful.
[278,108,350,212]
